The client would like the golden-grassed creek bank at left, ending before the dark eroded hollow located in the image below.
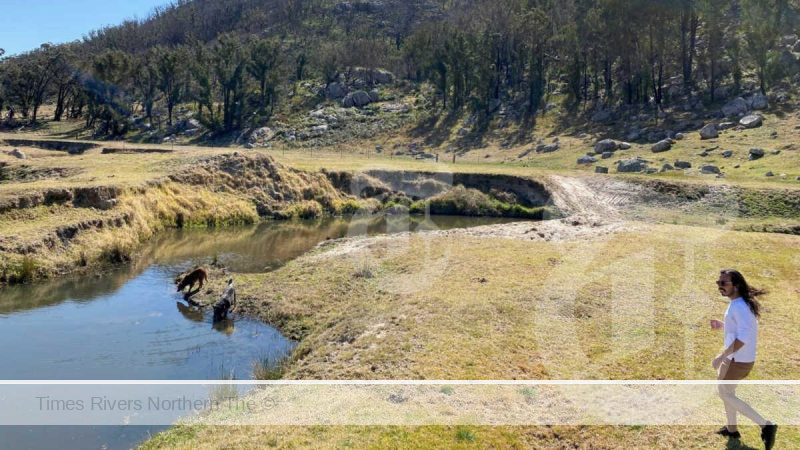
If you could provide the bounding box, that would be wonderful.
[0,153,345,284]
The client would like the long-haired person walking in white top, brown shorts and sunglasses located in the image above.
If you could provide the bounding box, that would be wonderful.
[711,270,778,450]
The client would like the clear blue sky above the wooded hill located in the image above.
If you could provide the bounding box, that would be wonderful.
[0,0,169,56]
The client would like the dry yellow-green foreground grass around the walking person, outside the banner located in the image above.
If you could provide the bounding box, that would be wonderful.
[145,225,800,449]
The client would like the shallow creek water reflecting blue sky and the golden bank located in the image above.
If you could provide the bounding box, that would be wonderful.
[0,216,507,449]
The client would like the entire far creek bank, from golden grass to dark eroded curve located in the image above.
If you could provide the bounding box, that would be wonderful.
[0,152,555,283]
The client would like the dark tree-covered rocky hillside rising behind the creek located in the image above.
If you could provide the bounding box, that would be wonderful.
[0,0,800,153]
